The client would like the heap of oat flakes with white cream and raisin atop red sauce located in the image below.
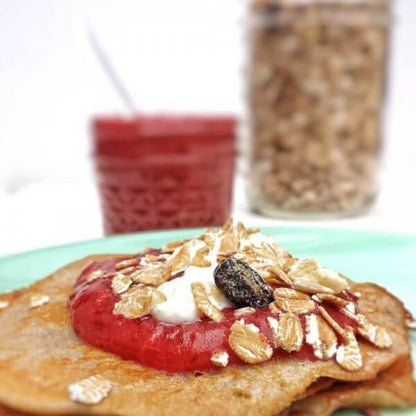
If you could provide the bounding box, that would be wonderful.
[83,220,394,372]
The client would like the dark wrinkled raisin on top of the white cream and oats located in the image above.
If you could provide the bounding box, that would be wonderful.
[214,257,273,307]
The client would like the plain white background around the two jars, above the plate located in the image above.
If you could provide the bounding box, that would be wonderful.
[0,0,416,255]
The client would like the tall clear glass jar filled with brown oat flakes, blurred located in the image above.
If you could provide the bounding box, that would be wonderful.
[248,0,391,218]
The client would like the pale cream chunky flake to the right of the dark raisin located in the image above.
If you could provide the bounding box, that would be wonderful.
[288,259,348,293]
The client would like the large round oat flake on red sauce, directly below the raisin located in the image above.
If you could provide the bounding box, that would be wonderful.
[228,320,273,364]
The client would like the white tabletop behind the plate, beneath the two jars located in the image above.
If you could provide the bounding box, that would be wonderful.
[0,170,416,256]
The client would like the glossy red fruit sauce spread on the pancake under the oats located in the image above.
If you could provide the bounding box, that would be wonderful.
[69,254,357,372]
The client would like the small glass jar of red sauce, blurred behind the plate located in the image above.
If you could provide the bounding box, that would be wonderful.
[92,116,236,234]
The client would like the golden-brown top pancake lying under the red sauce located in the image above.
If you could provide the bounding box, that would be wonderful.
[0,255,410,416]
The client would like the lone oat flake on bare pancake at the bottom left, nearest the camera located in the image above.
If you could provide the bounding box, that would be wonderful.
[68,375,112,405]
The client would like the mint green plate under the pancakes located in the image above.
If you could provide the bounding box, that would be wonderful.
[0,227,416,416]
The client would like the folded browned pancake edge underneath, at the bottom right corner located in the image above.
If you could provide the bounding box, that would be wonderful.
[284,356,416,416]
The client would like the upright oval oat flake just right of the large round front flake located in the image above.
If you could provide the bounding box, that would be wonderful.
[276,313,304,352]
